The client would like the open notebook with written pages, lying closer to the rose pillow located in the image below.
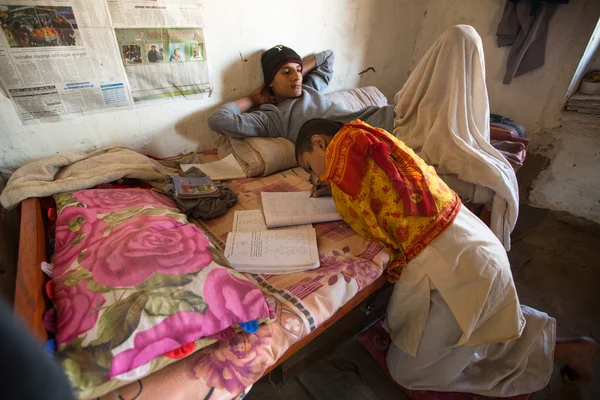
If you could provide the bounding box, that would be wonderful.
[225,210,320,275]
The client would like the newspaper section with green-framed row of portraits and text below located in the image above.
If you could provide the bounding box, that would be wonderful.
[115,28,210,103]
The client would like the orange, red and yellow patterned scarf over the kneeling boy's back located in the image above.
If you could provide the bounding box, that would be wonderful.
[321,120,461,282]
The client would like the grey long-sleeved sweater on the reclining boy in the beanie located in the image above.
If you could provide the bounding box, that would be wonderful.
[208,50,394,142]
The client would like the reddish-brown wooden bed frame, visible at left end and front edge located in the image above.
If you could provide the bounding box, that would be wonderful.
[14,198,387,375]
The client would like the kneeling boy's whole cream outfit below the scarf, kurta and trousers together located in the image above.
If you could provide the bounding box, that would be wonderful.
[387,207,556,397]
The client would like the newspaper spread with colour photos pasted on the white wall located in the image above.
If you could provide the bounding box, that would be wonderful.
[0,0,210,123]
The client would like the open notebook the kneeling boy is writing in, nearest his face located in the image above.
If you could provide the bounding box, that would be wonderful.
[261,192,342,228]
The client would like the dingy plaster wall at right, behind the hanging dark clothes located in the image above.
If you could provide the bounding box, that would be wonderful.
[412,0,600,222]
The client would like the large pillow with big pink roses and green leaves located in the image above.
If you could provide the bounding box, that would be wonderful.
[52,189,270,398]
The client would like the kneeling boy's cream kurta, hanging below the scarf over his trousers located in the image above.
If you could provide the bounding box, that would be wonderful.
[388,207,525,356]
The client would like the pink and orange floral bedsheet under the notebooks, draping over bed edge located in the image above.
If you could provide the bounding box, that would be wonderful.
[102,168,389,400]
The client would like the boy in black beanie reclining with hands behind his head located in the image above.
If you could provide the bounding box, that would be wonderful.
[208,45,394,142]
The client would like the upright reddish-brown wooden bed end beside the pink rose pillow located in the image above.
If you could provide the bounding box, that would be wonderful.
[14,198,48,343]
